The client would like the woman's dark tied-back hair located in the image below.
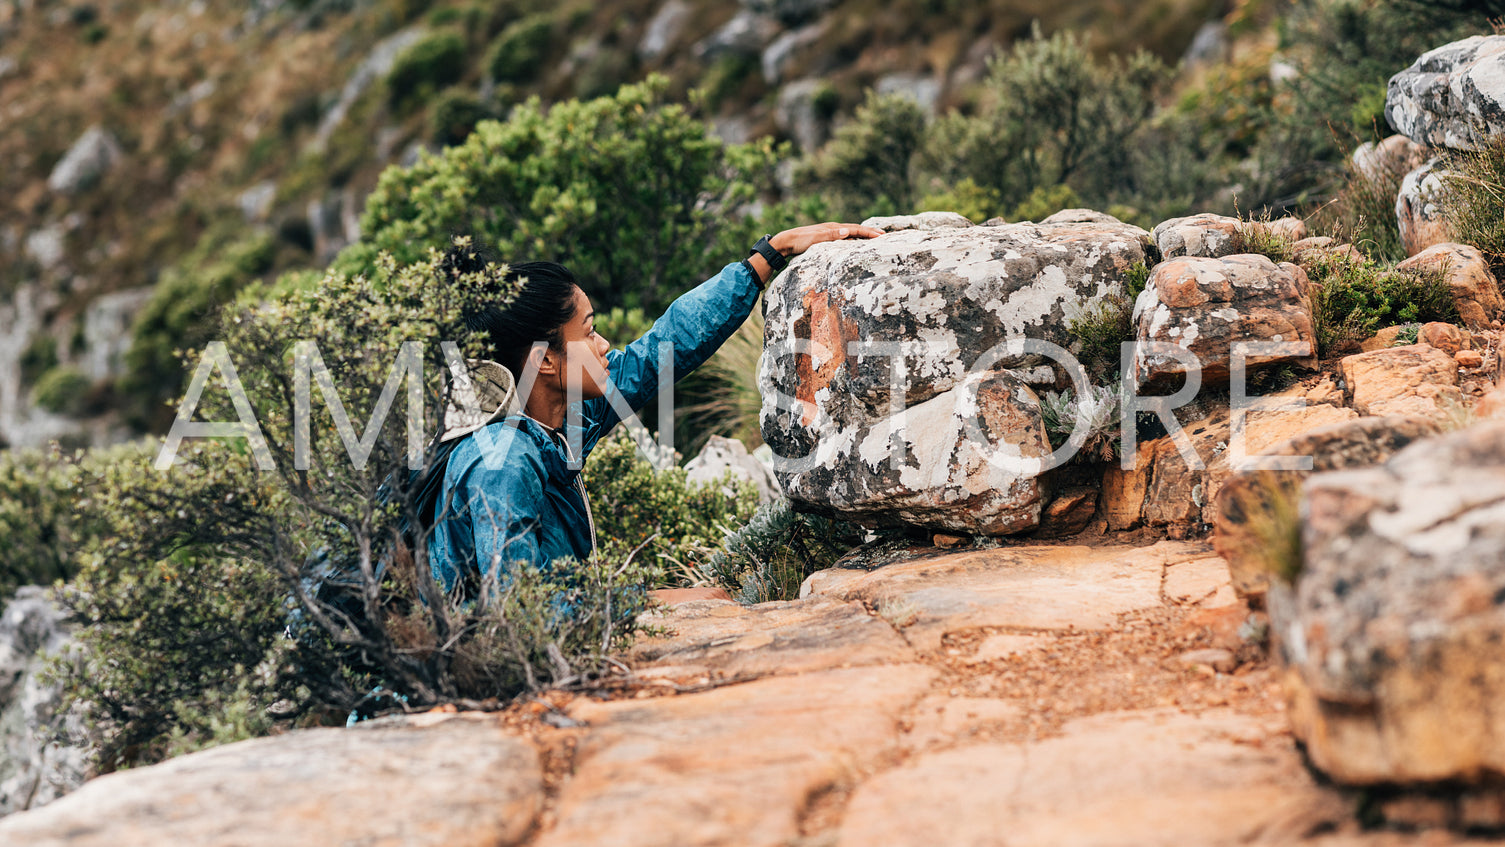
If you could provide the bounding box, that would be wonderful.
[439,245,578,381]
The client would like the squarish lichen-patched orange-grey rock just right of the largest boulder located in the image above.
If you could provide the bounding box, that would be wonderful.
[1133,253,1317,387]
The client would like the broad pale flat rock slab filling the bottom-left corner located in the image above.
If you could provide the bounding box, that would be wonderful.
[0,716,543,847]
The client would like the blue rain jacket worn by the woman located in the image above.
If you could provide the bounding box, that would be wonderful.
[429,262,759,588]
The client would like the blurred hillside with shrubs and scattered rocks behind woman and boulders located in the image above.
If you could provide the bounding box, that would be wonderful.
[0,0,1499,447]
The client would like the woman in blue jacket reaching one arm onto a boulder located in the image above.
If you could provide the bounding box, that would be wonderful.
[429,223,882,603]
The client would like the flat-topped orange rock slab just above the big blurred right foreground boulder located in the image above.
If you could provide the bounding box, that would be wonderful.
[1338,345,1463,420]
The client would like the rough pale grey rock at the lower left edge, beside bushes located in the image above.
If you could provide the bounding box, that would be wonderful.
[0,585,90,815]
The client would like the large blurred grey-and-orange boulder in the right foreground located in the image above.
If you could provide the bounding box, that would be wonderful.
[1270,421,1505,785]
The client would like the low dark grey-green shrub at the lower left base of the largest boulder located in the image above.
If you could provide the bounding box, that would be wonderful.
[706,498,864,603]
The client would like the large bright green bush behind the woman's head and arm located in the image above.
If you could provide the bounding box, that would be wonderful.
[347,77,775,311]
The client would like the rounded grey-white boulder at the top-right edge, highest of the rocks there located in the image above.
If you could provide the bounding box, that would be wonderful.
[1385,35,1505,150]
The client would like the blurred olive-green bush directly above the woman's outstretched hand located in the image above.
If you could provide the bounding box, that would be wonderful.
[795,92,926,220]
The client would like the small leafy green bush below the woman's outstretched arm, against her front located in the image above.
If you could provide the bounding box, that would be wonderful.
[585,429,757,578]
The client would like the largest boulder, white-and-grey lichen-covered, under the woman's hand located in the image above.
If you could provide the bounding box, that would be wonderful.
[759,223,1147,534]
